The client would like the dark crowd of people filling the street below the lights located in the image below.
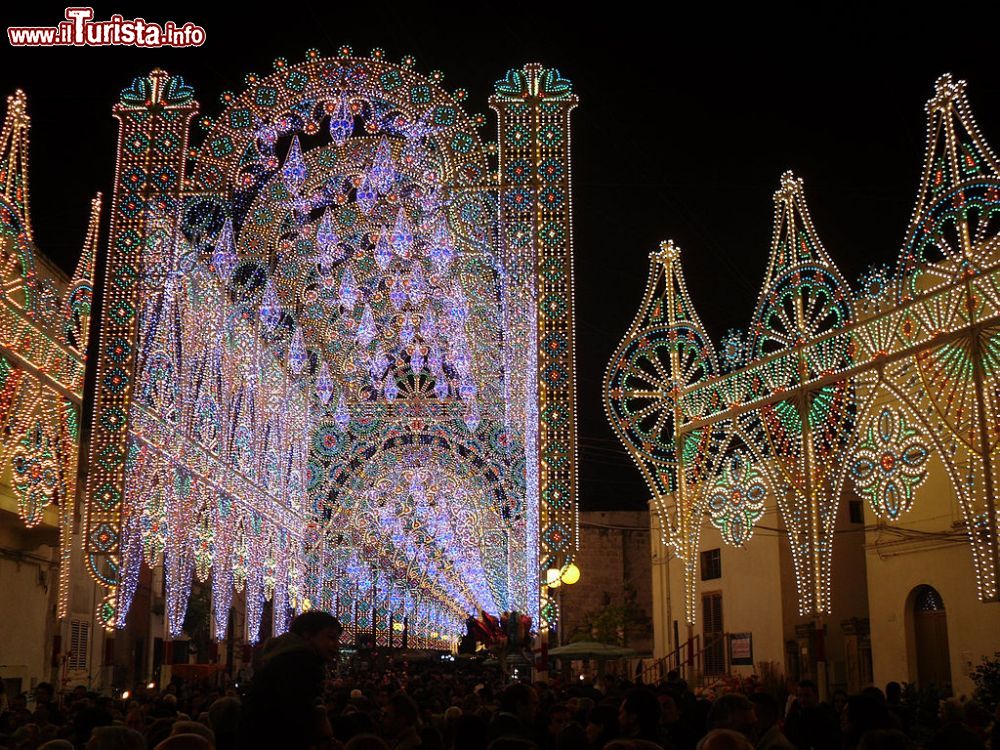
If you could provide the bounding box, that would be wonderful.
[0,612,1000,750]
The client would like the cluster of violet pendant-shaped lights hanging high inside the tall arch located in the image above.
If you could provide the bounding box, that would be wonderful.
[244,103,482,440]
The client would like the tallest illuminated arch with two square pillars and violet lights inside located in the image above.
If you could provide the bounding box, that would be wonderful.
[85,48,576,646]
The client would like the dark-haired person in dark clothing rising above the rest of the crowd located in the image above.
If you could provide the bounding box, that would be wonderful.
[240,610,343,750]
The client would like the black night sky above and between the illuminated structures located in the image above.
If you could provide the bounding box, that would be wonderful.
[0,7,1000,509]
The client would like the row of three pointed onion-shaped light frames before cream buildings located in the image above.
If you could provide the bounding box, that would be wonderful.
[604,75,1000,624]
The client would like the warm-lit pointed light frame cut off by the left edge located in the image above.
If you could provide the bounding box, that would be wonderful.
[0,91,101,617]
